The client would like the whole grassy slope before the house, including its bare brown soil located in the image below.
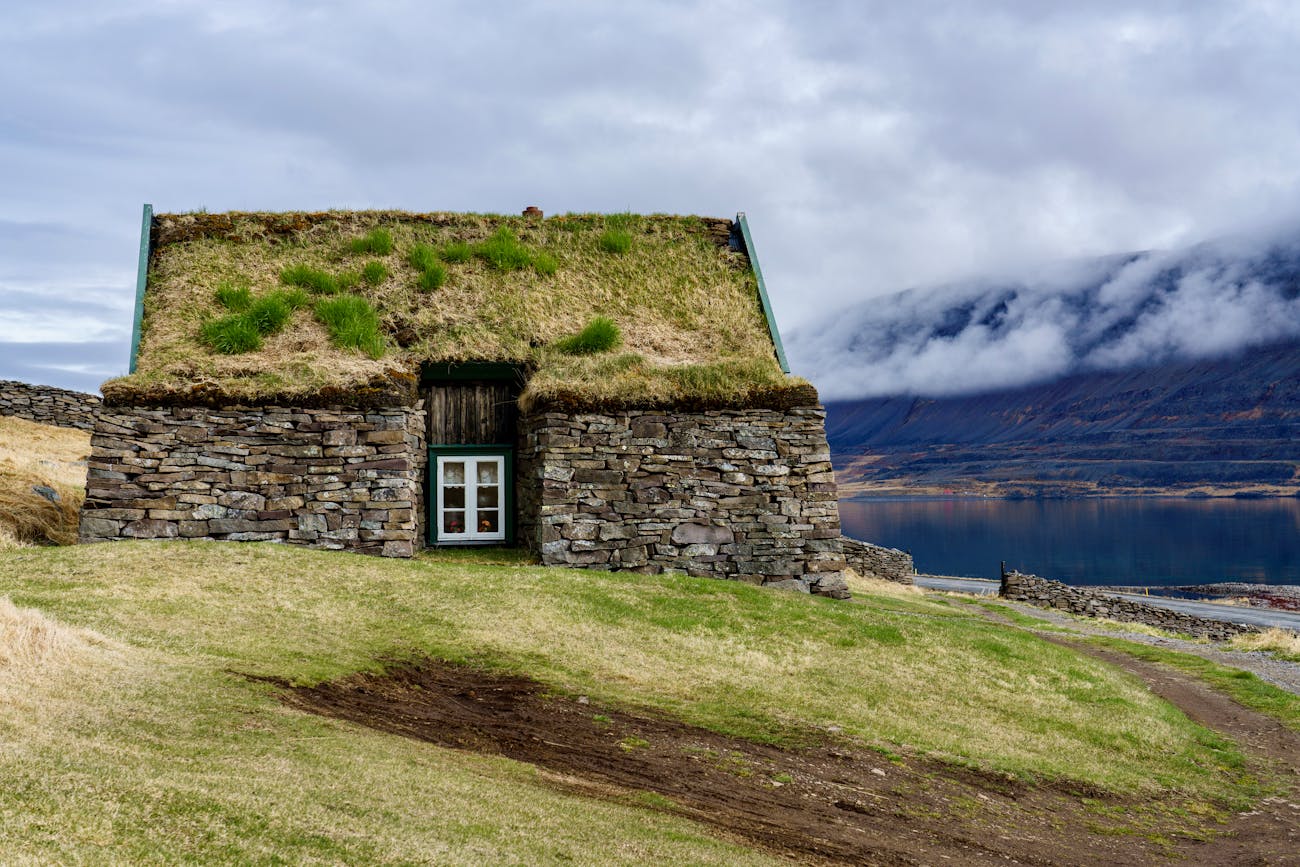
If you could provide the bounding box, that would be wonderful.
[0,542,1294,864]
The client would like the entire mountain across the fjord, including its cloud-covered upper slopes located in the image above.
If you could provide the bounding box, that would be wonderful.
[790,233,1300,495]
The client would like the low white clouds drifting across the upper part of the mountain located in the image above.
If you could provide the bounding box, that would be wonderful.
[788,226,1300,400]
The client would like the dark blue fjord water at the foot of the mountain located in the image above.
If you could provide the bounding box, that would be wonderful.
[840,498,1300,586]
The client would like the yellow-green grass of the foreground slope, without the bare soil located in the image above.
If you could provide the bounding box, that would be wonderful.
[0,542,1279,863]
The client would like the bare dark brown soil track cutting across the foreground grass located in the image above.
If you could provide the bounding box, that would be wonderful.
[266,659,1300,866]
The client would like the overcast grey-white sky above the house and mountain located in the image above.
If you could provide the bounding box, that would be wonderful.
[0,0,1300,389]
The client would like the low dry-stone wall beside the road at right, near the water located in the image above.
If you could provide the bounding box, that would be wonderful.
[1001,572,1258,641]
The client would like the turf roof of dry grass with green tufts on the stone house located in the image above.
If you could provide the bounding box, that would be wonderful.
[103,212,816,408]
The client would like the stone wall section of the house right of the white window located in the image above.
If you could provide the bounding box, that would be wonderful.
[517,407,848,598]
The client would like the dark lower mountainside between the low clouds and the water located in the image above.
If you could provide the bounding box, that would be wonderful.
[827,343,1300,495]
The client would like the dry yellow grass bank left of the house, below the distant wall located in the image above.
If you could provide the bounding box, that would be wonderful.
[0,416,90,549]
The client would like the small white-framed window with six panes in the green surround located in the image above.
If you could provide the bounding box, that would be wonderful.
[437,455,506,543]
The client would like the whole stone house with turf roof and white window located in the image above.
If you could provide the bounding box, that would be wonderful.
[81,205,846,595]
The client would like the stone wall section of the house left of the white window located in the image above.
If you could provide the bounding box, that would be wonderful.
[81,406,426,556]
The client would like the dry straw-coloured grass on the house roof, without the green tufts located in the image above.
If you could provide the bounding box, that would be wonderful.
[105,213,783,408]
